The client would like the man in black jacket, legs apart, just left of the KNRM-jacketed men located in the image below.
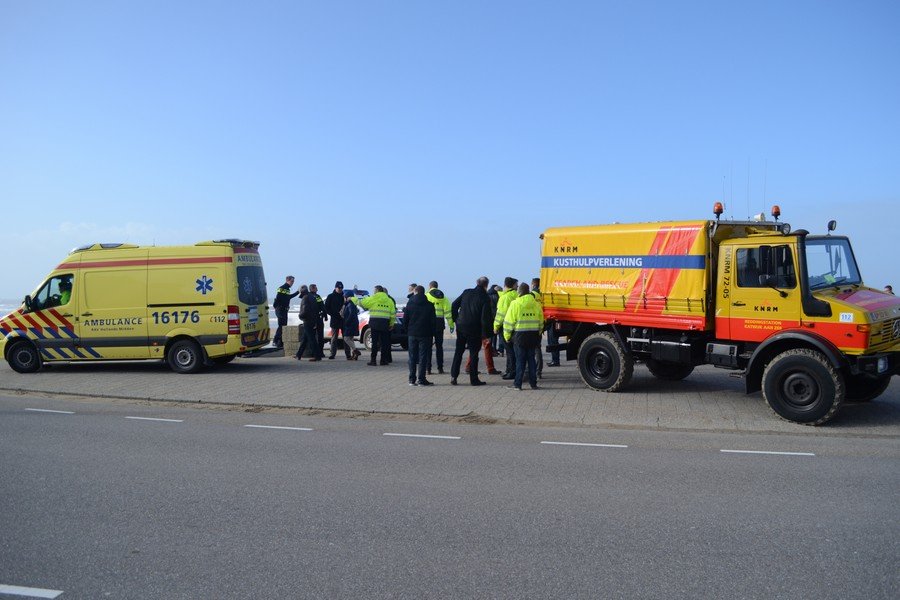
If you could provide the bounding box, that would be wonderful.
[450,277,491,385]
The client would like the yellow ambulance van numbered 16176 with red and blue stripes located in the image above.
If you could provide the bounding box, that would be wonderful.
[0,239,269,373]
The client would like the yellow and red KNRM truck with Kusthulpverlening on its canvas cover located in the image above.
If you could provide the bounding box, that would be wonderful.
[541,203,900,425]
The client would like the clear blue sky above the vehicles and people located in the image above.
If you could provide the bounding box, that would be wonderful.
[0,0,900,298]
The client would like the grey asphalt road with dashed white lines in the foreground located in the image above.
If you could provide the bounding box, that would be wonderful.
[0,396,900,600]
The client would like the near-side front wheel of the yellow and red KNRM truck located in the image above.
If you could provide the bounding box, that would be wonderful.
[762,348,845,425]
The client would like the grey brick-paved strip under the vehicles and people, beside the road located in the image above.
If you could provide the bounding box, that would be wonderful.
[0,351,900,436]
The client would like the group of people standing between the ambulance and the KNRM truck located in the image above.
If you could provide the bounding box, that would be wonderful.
[273,276,559,390]
